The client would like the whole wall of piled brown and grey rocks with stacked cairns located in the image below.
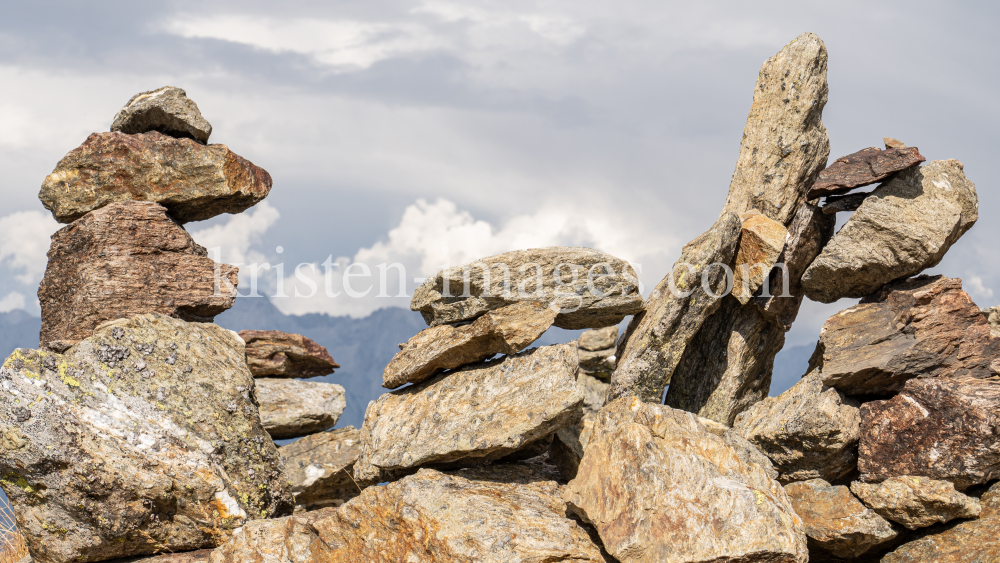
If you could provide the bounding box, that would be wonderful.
[0,33,1000,563]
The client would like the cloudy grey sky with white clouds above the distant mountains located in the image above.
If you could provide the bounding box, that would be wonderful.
[0,0,1000,352]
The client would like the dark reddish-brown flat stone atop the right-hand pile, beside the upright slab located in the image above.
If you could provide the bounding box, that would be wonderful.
[806,147,927,199]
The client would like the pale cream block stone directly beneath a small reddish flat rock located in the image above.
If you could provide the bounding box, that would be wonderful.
[256,378,347,440]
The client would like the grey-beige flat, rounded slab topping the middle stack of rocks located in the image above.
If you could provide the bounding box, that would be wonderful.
[410,246,643,330]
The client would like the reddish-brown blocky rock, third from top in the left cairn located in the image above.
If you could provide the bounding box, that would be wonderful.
[38,201,238,350]
